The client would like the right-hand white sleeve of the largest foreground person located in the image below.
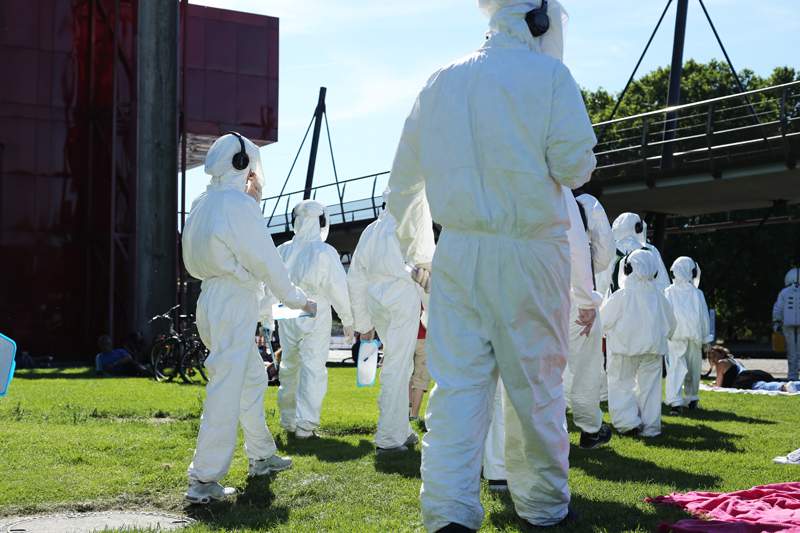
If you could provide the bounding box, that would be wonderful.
[547,63,597,189]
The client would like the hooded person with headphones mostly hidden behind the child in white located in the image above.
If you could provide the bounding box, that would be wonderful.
[597,213,669,296]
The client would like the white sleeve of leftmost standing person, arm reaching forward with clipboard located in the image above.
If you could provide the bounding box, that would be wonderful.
[228,198,308,309]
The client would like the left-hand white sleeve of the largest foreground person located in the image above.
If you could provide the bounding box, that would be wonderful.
[387,96,435,265]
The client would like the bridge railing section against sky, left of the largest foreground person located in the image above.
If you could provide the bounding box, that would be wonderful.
[261,171,389,233]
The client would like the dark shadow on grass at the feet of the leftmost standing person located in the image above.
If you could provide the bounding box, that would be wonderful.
[185,476,289,531]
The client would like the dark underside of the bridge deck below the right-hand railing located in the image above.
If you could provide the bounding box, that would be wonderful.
[589,162,800,222]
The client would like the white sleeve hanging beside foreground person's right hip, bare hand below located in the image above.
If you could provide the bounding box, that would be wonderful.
[562,186,603,309]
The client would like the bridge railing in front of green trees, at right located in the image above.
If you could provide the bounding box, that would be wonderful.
[591,82,800,187]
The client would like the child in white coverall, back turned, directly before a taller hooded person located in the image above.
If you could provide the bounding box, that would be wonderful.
[600,250,677,437]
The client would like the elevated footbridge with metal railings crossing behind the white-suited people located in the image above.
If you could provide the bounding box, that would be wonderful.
[262,82,800,255]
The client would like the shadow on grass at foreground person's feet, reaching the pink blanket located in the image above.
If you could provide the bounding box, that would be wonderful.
[484,493,692,533]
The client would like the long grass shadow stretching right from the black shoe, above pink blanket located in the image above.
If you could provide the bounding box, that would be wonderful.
[569,444,722,492]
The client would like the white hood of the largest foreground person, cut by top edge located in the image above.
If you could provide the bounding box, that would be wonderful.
[478,0,569,62]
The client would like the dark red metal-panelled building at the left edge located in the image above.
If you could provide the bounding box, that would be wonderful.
[0,0,278,361]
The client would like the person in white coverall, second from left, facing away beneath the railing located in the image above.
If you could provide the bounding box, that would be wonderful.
[278,200,353,439]
